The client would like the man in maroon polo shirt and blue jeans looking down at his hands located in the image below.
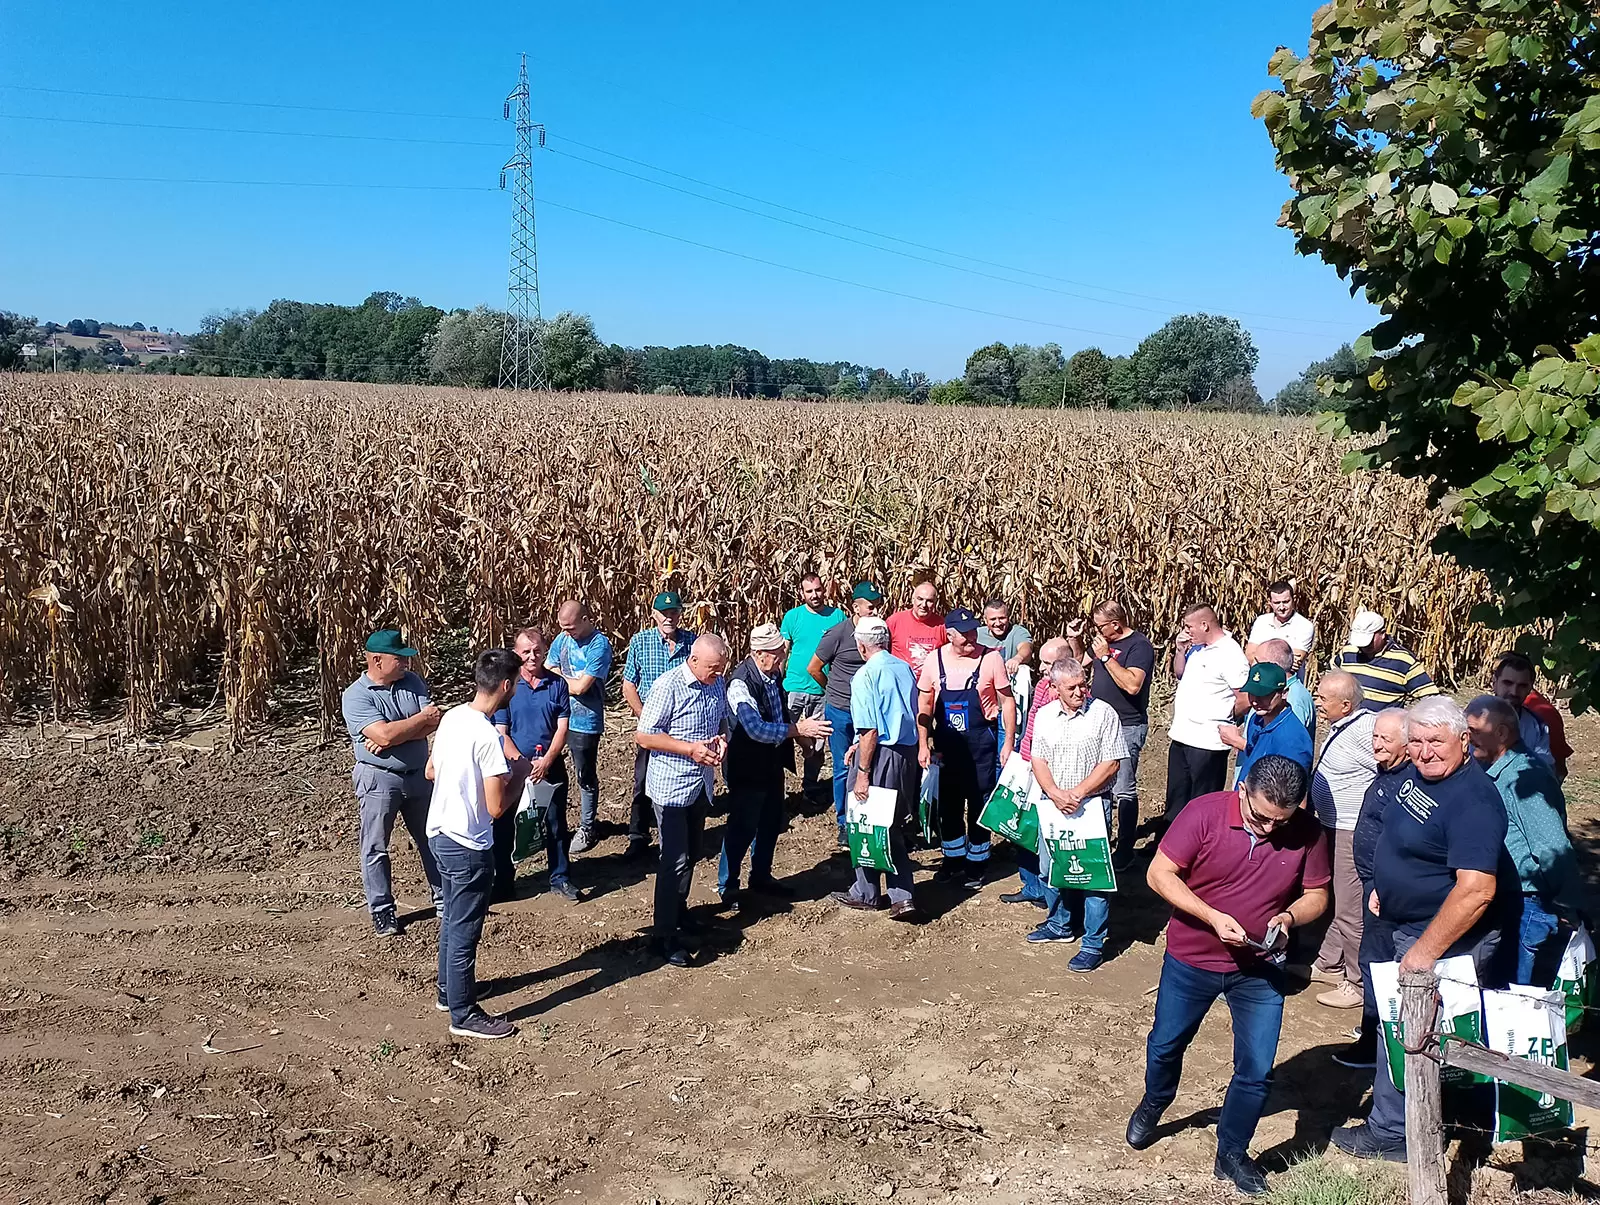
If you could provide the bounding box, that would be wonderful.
[1128,754,1333,1195]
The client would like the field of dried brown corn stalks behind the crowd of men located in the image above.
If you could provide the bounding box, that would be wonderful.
[0,376,1502,731]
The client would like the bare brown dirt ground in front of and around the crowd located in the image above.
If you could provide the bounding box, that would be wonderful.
[9,710,1600,1205]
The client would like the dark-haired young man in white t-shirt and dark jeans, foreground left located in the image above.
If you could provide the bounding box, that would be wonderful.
[427,648,522,1039]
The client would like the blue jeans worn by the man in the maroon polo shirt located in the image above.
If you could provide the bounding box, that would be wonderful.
[1144,954,1283,1155]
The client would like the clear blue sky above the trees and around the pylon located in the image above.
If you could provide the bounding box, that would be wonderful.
[0,0,1373,394]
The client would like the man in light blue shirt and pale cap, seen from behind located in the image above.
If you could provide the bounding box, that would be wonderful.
[829,616,922,920]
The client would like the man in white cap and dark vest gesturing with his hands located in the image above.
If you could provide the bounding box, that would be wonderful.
[717,624,832,912]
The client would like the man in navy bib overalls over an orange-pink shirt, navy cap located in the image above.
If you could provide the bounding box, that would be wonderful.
[917,604,1016,890]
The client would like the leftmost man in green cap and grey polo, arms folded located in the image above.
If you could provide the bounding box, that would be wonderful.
[342,627,442,938]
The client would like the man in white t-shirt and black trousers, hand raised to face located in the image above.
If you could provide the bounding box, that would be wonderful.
[1165,603,1250,824]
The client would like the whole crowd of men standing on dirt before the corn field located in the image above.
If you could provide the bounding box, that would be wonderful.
[344,574,1579,1192]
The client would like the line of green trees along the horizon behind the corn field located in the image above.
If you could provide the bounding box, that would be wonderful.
[0,291,1358,413]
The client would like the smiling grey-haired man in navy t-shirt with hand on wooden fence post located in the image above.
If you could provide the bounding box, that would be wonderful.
[1333,695,1520,1162]
